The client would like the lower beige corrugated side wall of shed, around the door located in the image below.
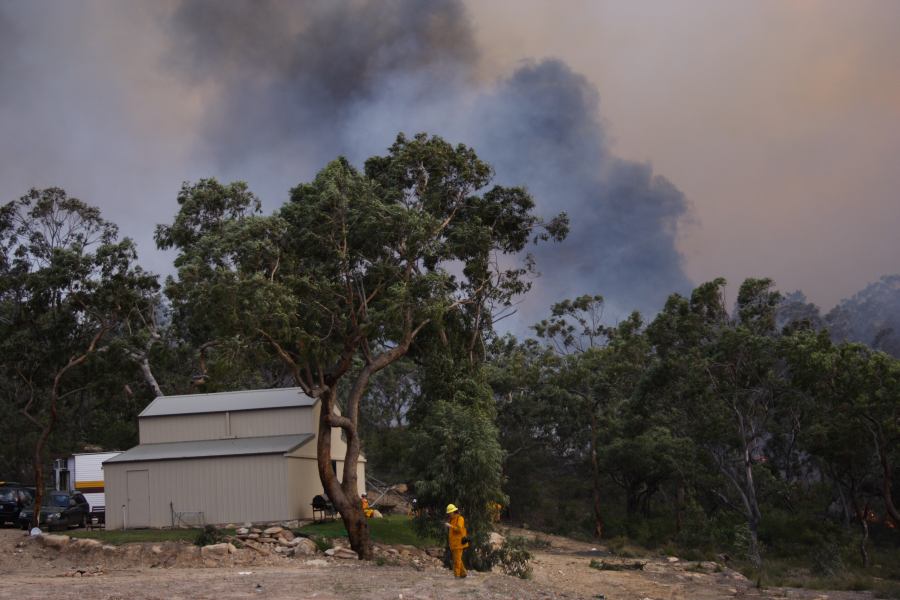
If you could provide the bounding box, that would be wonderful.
[104,454,292,529]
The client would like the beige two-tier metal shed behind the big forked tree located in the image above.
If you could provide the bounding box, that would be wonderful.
[103,388,365,529]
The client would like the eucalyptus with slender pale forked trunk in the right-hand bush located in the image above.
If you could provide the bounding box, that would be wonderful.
[648,278,789,565]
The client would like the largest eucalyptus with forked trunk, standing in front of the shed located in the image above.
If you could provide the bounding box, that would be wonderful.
[157,134,566,559]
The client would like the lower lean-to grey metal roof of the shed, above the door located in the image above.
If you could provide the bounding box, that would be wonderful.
[103,433,314,465]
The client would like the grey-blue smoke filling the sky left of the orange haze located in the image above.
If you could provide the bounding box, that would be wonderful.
[0,0,691,330]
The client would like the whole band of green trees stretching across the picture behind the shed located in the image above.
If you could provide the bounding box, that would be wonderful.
[0,134,900,565]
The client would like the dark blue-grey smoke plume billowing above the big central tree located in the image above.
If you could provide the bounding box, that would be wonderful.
[165,0,691,323]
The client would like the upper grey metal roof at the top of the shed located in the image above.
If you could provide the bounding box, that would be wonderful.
[138,388,316,417]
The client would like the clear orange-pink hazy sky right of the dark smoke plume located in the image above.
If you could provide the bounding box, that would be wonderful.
[470,0,900,310]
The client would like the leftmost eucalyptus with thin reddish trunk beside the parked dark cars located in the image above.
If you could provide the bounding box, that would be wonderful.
[0,188,158,523]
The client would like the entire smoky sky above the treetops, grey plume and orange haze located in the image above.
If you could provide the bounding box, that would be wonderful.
[0,0,900,324]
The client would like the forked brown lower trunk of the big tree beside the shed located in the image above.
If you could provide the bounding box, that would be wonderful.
[316,388,373,560]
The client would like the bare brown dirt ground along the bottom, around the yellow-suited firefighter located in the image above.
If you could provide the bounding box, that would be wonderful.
[0,529,872,600]
